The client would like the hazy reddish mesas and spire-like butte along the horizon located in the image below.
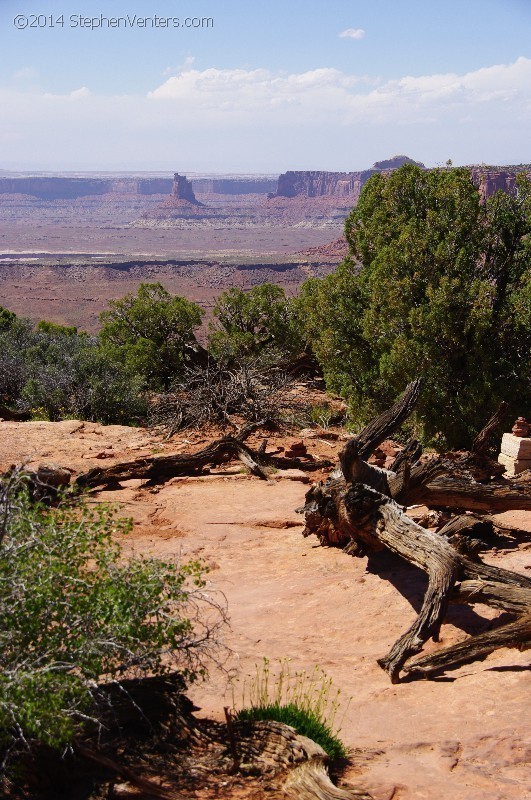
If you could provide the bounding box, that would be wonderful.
[0,155,531,211]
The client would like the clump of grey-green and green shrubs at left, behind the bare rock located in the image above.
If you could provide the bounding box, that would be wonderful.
[0,283,203,424]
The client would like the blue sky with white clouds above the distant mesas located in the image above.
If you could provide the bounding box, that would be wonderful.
[0,0,531,173]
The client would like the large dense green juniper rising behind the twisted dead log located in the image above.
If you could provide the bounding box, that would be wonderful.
[299,165,531,448]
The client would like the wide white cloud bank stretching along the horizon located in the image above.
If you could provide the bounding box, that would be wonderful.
[0,57,531,172]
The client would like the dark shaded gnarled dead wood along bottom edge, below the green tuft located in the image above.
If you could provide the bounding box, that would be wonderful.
[19,675,371,800]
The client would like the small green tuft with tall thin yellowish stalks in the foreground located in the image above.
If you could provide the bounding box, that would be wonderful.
[234,658,350,760]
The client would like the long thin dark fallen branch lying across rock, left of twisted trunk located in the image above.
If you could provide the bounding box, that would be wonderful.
[75,434,332,488]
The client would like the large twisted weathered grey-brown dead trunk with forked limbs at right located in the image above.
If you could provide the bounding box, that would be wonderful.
[303,382,531,682]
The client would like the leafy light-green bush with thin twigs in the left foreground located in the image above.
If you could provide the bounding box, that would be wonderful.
[0,472,226,789]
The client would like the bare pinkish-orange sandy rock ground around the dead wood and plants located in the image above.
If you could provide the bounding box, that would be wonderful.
[0,421,531,800]
